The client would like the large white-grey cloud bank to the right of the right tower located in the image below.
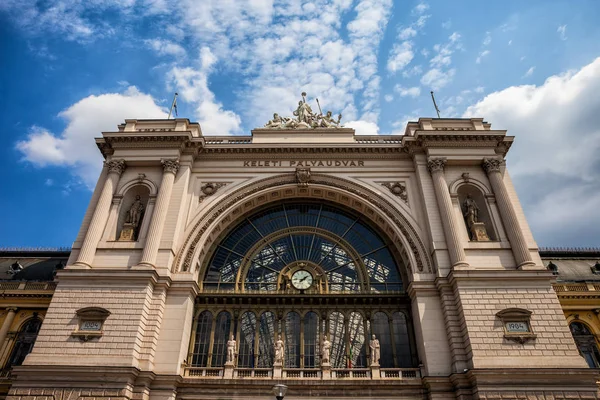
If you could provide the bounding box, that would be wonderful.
[464,58,600,246]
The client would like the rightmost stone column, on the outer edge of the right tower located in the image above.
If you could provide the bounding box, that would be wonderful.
[483,158,535,268]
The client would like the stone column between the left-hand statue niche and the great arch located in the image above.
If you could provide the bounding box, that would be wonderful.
[140,159,179,268]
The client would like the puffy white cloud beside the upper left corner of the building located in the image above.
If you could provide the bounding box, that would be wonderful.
[16,86,167,187]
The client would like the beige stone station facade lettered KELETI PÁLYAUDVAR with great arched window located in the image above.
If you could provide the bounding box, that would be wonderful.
[0,113,598,400]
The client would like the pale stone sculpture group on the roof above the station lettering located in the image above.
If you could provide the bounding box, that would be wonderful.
[265,92,342,129]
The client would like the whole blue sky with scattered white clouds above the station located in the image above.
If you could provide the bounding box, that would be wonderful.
[0,0,600,246]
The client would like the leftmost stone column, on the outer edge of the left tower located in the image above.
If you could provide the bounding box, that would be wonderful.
[74,160,125,268]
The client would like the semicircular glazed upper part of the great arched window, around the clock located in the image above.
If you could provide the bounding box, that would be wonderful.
[203,203,402,292]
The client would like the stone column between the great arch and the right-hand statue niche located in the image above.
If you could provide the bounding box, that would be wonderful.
[427,158,469,268]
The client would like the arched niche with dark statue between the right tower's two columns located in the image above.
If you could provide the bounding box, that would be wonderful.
[457,184,498,242]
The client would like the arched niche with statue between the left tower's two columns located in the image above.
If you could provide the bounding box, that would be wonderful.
[117,185,150,242]
